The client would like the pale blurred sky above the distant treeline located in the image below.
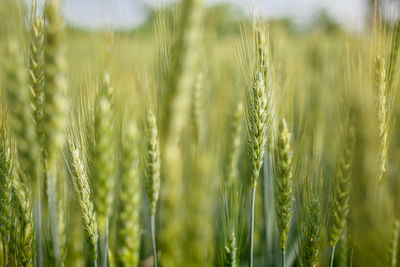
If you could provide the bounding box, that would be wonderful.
[36,0,366,29]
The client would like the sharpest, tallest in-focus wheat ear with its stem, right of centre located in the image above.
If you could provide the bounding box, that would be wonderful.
[247,72,272,267]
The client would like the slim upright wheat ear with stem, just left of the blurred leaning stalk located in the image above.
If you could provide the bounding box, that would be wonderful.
[146,111,161,266]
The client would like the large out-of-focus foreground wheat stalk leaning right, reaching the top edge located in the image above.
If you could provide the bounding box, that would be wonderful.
[160,0,203,267]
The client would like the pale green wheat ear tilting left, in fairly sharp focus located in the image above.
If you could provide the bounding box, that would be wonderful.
[69,144,98,263]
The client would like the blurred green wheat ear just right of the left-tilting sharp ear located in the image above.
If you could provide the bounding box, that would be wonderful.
[92,73,115,234]
